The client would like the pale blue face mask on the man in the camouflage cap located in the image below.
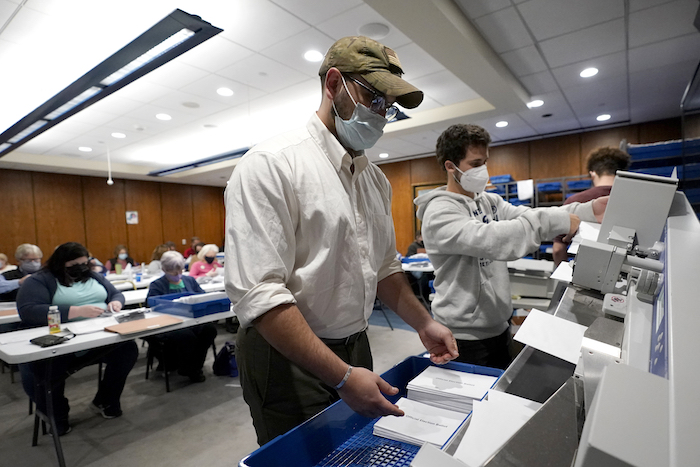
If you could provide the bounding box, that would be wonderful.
[333,75,387,151]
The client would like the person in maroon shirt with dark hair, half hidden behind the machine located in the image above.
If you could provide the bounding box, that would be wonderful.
[552,147,631,267]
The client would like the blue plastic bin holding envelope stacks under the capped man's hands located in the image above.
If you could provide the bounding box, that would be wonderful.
[239,357,503,467]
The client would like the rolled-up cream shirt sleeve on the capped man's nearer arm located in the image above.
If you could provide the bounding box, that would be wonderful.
[225,152,298,328]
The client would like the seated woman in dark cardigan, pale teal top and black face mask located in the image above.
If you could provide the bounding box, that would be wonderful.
[17,242,139,435]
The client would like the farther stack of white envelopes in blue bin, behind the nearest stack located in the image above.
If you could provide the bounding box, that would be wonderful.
[406,366,497,413]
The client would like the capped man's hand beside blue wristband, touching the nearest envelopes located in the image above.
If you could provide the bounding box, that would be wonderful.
[338,367,404,418]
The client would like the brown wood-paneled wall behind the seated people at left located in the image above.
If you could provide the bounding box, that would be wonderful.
[0,169,224,262]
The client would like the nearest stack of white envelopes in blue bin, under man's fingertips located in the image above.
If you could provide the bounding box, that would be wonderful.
[373,398,467,448]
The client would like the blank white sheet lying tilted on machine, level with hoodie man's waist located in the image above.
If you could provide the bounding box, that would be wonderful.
[514,308,587,365]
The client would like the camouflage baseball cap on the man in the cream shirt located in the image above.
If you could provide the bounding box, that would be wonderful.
[318,36,423,109]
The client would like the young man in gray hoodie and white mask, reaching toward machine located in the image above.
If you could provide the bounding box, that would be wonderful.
[414,124,608,368]
